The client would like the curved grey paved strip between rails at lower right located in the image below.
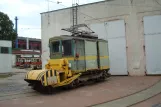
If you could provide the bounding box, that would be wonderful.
[93,77,161,107]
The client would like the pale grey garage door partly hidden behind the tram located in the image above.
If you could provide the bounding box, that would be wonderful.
[90,20,128,75]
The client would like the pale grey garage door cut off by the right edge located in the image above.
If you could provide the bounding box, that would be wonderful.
[144,15,161,74]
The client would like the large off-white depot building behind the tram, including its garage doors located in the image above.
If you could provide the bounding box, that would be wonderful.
[41,0,161,76]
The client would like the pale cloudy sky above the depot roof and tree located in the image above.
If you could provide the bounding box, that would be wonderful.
[0,0,102,38]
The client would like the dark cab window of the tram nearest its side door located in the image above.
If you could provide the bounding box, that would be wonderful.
[62,40,72,56]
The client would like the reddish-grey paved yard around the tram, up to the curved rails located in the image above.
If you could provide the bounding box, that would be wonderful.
[0,70,161,107]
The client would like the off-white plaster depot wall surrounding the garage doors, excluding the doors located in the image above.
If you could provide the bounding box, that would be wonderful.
[41,0,161,75]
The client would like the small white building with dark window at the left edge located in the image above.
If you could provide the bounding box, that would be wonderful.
[0,40,12,73]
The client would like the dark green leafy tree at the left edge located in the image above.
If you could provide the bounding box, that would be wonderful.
[0,12,17,41]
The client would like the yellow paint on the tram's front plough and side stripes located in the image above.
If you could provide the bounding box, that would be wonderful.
[25,56,109,87]
